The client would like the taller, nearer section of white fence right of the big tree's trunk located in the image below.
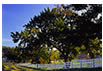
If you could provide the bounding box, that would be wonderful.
[67,58,102,68]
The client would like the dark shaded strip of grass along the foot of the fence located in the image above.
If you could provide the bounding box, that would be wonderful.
[21,66,102,71]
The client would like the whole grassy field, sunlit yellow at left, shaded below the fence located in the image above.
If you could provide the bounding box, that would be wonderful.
[2,63,102,71]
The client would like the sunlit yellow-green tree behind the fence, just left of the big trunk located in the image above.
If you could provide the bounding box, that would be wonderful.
[38,47,60,64]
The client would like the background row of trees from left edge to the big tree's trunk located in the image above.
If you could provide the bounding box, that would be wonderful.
[2,46,60,64]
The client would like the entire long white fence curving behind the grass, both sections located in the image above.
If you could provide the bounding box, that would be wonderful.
[17,58,102,69]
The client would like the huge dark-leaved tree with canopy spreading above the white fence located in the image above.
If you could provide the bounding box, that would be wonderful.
[11,4,102,67]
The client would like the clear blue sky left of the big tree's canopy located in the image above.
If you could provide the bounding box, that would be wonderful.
[2,4,55,47]
